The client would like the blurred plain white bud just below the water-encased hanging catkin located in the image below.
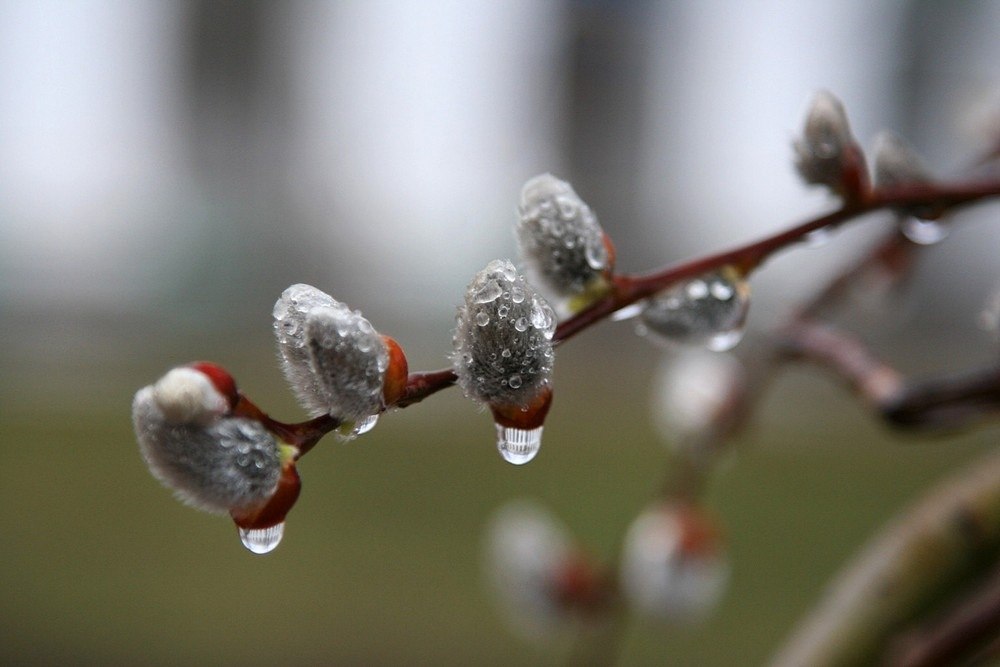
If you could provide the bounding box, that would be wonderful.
[653,350,748,460]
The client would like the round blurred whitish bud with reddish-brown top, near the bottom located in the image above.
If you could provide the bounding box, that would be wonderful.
[621,503,729,622]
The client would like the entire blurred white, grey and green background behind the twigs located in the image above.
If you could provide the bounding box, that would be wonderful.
[0,0,1000,665]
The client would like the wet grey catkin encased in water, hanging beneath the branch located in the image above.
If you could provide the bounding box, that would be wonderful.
[636,267,750,352]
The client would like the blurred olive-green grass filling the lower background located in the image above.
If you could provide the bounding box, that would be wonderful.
[0,337,995,665]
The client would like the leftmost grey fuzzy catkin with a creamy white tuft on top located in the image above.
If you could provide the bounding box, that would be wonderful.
[132,376,282,513]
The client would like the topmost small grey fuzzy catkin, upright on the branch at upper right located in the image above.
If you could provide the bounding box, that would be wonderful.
[794,91,854,190]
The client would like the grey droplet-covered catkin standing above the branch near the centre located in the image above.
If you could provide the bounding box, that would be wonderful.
[517,174,615,315]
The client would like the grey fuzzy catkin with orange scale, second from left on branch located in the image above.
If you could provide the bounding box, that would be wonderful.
[274,284,407,437]
